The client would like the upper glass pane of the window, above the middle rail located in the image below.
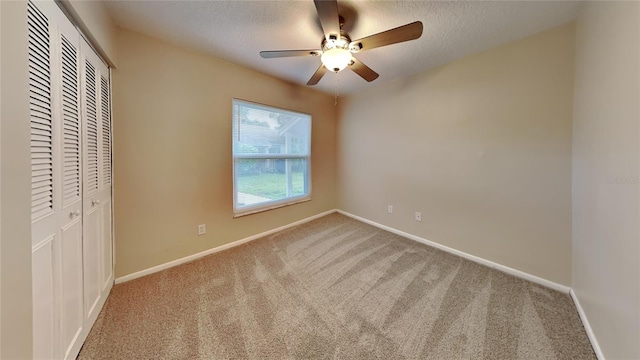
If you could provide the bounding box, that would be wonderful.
[233,100,311,155]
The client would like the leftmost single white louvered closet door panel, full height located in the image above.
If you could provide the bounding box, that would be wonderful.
[27,2,59,359]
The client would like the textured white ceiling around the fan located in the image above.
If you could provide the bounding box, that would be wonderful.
[105,0,580,94]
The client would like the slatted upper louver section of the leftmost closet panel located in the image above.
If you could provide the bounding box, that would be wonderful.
[27,2,53,219]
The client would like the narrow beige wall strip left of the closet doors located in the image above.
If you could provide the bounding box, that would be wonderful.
[0,1,32,359]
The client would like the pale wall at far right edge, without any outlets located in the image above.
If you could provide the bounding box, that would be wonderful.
[572,2,640,359]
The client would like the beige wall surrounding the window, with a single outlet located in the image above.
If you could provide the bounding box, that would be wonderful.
[112,30,336,277]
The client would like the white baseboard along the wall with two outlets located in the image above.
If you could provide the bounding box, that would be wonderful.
[337,210,570,294]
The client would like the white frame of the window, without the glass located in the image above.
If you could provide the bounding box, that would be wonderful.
[231,98,313,218]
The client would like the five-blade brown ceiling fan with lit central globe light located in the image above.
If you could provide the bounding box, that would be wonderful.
[260,0,422,85]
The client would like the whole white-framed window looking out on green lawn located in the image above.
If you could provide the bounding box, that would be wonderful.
[233,99,311,216]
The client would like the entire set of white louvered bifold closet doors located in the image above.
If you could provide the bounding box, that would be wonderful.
[26,1,113,359]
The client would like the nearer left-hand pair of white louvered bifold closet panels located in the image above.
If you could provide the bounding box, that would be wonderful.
[27,2,84,358]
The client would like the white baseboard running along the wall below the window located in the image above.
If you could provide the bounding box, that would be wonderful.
[115,209,337,284]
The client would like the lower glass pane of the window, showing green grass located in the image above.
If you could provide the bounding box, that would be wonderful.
[235,159,308,208]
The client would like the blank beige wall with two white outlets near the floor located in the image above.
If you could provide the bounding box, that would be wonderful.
[338,23,575,285]
